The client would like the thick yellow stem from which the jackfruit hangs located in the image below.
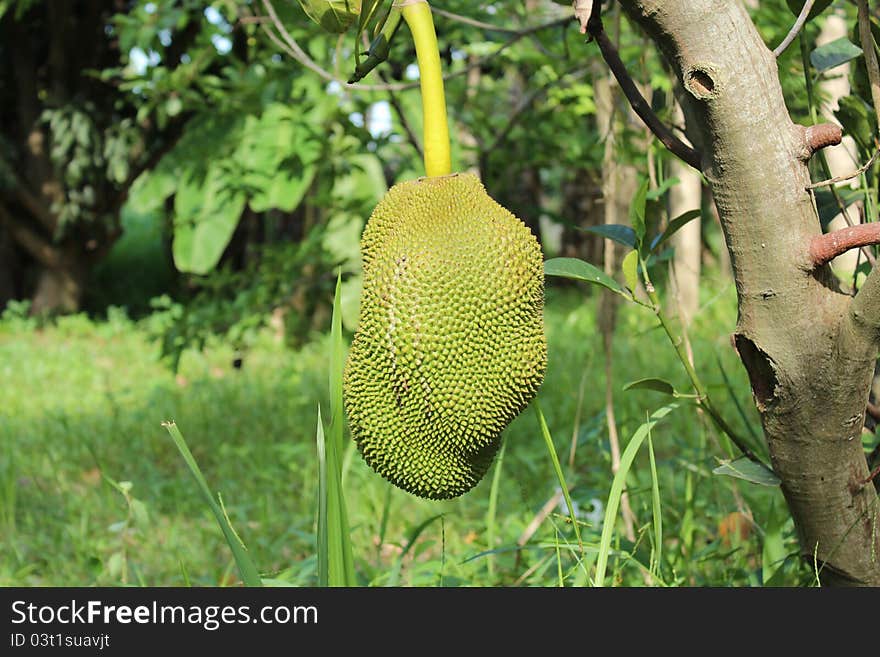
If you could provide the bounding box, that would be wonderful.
[397,0,452,177]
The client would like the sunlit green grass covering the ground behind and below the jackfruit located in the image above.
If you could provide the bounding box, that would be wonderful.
[0,274,811,586]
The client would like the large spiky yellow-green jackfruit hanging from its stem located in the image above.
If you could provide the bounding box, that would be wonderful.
[343,174,547,499]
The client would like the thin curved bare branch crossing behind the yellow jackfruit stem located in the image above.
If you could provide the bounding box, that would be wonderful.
[252,0,571,91]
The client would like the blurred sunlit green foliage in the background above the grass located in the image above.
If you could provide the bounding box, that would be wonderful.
[0,0,874,346]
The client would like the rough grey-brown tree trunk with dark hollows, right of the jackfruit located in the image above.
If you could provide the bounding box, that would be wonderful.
[621,0,880,586]
